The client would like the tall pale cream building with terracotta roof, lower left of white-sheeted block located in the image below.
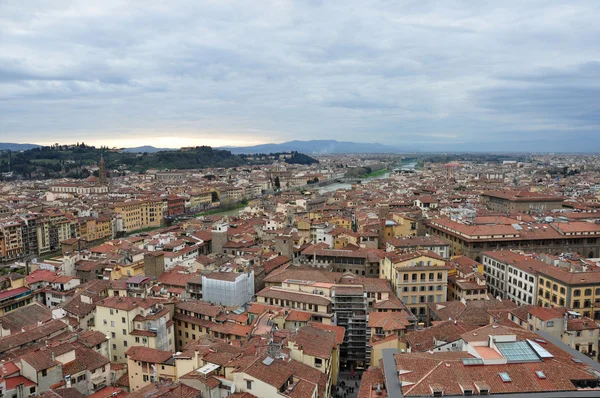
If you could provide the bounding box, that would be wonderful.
[92,297,175,362]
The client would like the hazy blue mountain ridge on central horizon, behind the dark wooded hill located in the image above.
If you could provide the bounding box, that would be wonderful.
[221,140,400,155]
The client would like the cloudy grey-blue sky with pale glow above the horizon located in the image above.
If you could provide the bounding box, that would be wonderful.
[0,0,600,151]
